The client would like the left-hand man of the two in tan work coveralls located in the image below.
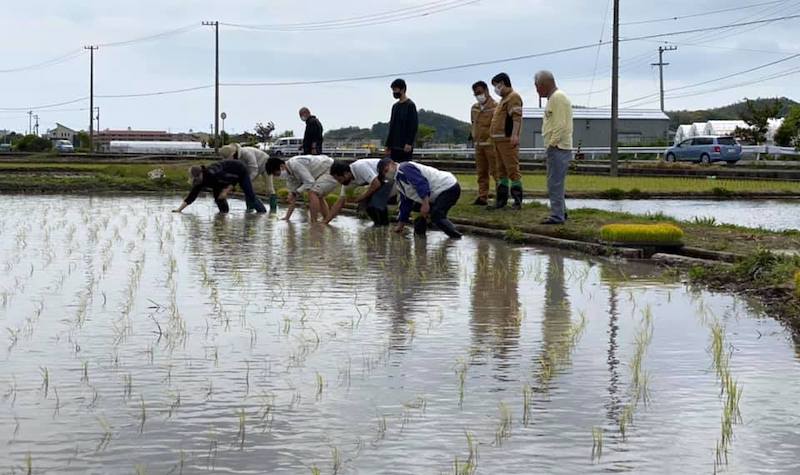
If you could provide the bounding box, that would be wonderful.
[470,81,497,206]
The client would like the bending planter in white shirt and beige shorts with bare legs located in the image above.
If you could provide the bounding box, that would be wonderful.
[266,155,339,223]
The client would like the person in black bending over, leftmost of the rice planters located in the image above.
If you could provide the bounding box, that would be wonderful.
[173,160,267,213]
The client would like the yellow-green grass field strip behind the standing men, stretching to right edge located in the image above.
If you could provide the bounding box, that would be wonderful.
[456,174,800,198]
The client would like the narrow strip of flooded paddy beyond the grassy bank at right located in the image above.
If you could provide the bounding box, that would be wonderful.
[535,199,800,231]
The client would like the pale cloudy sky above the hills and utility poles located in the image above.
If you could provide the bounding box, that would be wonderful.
[0,0,800,133]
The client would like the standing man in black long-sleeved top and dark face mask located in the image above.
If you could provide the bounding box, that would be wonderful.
[386,79,419,163]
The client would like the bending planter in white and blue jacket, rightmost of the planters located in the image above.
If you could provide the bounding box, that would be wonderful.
[378,158,461,239]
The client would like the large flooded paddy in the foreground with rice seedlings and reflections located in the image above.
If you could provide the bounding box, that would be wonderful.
[0,196,800,474]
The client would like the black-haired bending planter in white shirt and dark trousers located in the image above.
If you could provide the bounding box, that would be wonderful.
[325,158,396,226]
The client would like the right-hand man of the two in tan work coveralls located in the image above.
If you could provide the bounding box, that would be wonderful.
[491,73,522,210]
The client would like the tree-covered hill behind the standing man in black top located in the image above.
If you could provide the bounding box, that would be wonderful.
[325,109,470,144]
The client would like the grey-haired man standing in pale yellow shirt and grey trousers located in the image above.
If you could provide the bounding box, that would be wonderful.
[534,71,572,225]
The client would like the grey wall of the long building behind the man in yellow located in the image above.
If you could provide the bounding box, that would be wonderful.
[521,118,669,148]
